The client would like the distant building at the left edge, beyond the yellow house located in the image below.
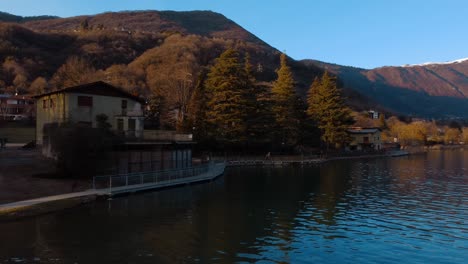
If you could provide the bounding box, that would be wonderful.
[0,94,36,121]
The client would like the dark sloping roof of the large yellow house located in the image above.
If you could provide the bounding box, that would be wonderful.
[33,81,145,104]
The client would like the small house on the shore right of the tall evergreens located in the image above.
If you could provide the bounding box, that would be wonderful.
[347,127,382,150]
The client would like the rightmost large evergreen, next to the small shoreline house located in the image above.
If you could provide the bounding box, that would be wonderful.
[307,72,353,150]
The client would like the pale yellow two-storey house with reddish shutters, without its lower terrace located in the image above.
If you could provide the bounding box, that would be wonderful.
[35,81,144,148]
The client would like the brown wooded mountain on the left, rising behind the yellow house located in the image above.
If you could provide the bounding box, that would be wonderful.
[0,11,323,95]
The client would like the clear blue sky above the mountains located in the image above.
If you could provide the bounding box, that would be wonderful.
[0,0,468,68]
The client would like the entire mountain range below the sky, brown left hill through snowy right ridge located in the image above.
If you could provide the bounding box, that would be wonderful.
[0,11,468,118]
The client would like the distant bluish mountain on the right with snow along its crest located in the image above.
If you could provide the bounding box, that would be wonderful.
[303,59,468,118]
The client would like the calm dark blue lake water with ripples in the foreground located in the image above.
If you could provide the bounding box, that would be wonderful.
[0,150,468,263]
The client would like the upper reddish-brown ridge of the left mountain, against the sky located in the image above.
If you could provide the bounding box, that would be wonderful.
[25,11,267,45]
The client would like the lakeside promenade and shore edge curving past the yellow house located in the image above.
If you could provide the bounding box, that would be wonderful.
[0,148,414,220]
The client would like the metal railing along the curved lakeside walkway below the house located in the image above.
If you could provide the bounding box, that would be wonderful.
[93,162,225,192]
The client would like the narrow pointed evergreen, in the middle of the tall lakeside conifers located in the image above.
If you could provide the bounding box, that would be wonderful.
[272,53,300,147]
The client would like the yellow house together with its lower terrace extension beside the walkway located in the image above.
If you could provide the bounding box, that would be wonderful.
[35,82,194,174]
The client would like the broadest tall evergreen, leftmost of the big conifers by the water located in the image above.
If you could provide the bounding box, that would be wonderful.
[206,49,249,144]
